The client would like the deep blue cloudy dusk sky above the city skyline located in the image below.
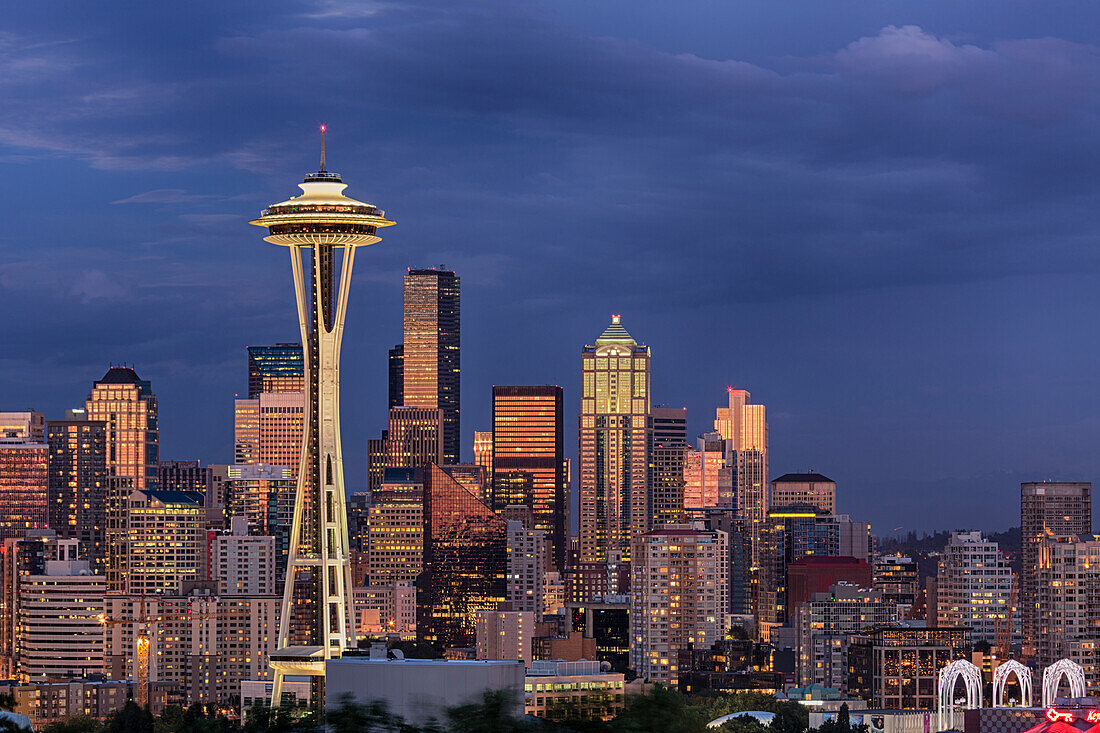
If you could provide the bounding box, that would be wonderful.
[0,0,1100,534]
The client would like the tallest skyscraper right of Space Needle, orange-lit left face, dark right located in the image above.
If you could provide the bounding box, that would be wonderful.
[402,267,461,463]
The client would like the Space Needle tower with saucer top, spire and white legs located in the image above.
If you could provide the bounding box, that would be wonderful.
[249,127,395,716]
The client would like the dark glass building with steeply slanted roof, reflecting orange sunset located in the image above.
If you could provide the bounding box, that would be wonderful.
[418,464,508,649]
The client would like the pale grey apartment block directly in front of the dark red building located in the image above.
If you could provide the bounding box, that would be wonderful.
[794,582,898,692]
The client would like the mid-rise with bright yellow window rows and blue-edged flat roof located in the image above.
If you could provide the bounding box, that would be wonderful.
[125,490,206,595]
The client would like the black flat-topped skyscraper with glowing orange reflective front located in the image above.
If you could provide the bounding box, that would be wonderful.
[493,385,569,570]
